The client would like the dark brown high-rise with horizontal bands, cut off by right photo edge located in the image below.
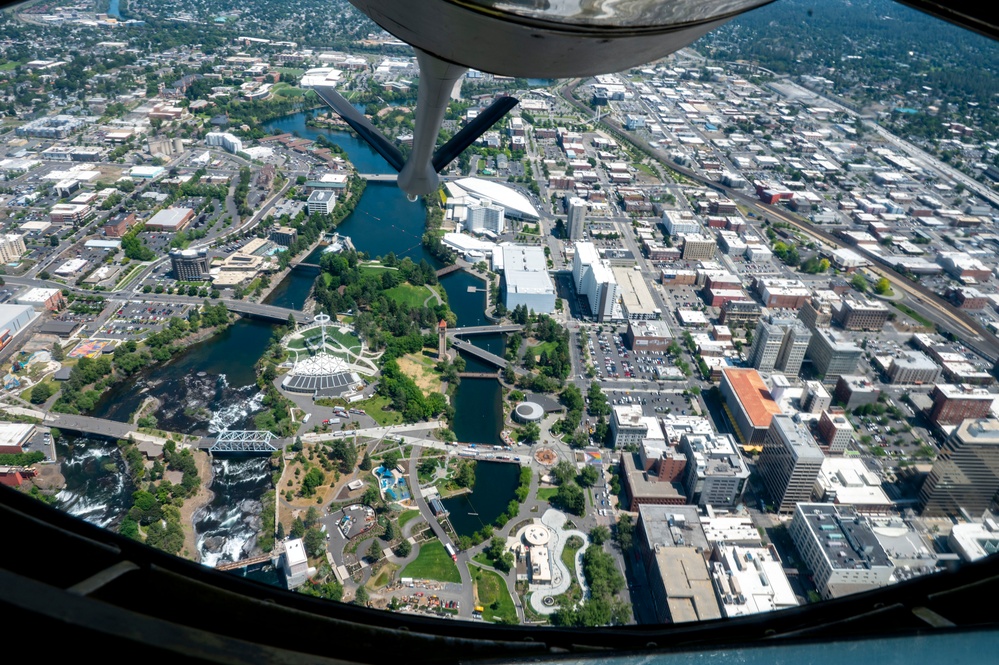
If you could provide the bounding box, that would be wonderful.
[919,420,999,517]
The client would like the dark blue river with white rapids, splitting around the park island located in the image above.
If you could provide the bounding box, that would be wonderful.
[53,113,504,565]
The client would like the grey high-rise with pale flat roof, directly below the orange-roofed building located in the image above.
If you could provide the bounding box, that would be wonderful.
[757,414,825,513]
